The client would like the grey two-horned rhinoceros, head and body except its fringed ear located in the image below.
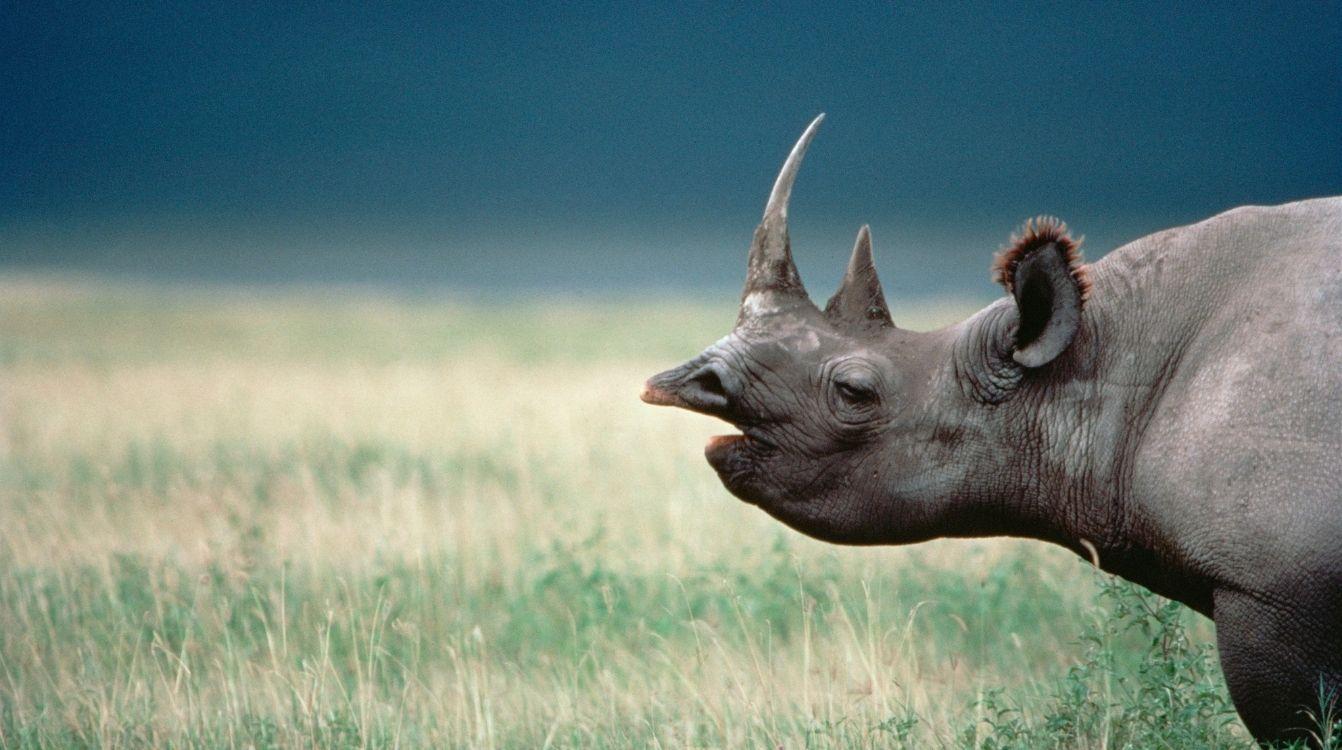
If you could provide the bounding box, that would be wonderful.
[644,117,1342,741]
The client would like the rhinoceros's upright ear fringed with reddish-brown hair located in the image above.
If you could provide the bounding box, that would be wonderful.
[993,216,1090,368]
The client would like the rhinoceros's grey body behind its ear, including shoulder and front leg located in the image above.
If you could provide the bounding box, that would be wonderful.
[1076,197,1342,738]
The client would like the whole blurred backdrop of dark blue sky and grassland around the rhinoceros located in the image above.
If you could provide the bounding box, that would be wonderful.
[0,1,1342,749]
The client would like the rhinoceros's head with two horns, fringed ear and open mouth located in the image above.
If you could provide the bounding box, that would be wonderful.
[643,115,1083,543]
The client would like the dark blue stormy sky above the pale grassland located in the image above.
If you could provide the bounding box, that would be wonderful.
[0,1,1342,294]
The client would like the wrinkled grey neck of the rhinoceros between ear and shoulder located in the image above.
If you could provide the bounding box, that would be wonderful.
[960,248,1209,609]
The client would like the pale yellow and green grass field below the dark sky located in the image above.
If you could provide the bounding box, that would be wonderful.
[0,278,1247,747]
